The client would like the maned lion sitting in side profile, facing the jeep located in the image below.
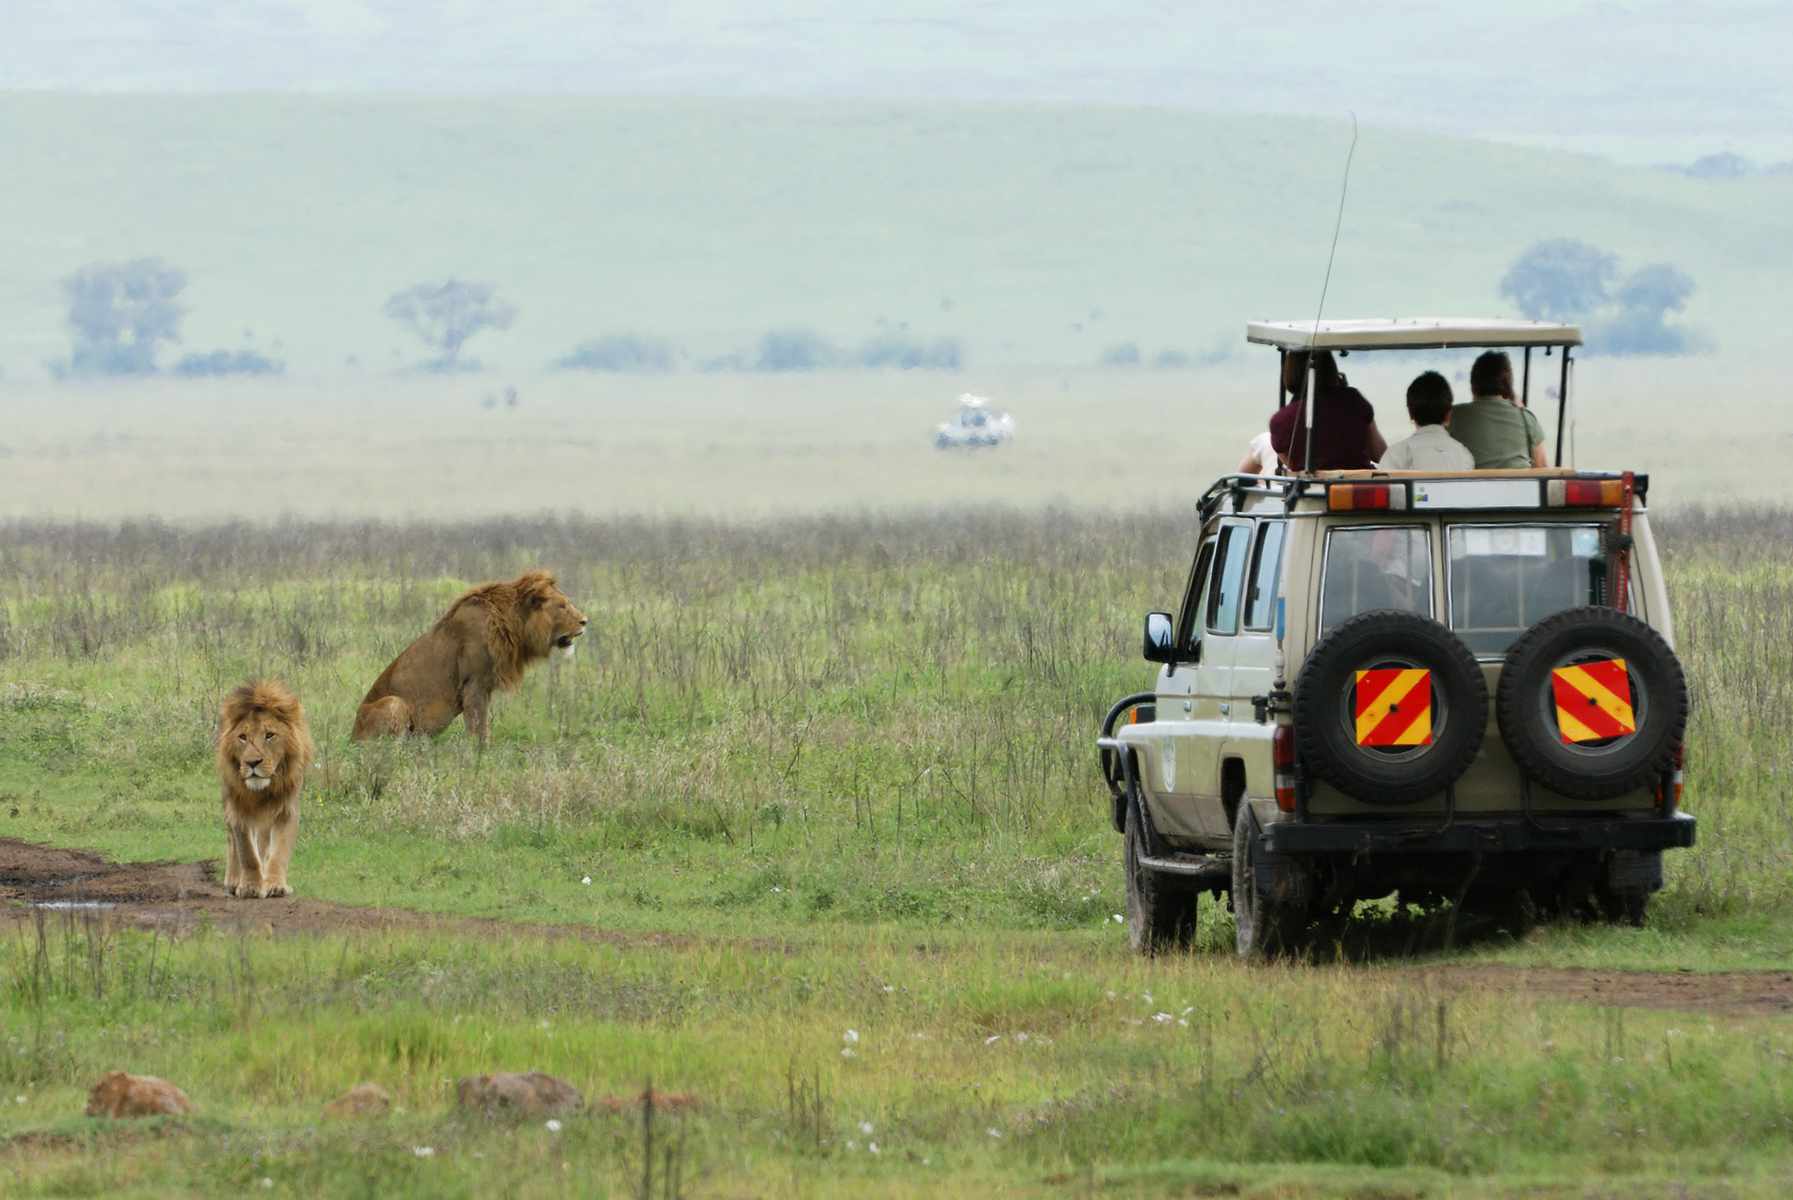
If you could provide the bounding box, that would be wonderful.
[355,570,588,746]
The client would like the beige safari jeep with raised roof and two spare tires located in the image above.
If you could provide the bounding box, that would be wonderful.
[1097,321,1694,956]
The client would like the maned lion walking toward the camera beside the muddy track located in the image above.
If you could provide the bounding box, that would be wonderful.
[219,680,312,900]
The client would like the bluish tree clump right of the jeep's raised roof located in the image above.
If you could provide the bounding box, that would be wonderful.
[1501,237,1703,355]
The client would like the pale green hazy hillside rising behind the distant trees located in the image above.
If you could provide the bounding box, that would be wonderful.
[0,93,1793,380]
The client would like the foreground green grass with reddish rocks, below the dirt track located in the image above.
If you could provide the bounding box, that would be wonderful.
[10,922,1793,1195]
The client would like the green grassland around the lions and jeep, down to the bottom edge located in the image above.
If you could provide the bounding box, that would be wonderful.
[0,508,1793,1196]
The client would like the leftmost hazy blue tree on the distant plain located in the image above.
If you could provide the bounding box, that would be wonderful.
[52,258,186,375]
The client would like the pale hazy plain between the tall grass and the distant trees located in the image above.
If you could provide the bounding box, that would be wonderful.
[0,351,1793,520]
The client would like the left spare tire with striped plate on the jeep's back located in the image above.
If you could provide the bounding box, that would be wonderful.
[1295,608,1488,805]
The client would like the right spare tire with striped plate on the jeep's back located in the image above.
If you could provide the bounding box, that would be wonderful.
[1495,606,1687,800]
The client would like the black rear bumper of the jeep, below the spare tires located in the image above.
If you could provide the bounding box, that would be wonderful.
[1260,813,1694,854]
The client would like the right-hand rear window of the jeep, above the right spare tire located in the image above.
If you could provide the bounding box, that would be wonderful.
[1445,526,1607,658]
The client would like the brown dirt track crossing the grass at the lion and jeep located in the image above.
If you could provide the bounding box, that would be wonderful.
[0,838,1793,1015]
